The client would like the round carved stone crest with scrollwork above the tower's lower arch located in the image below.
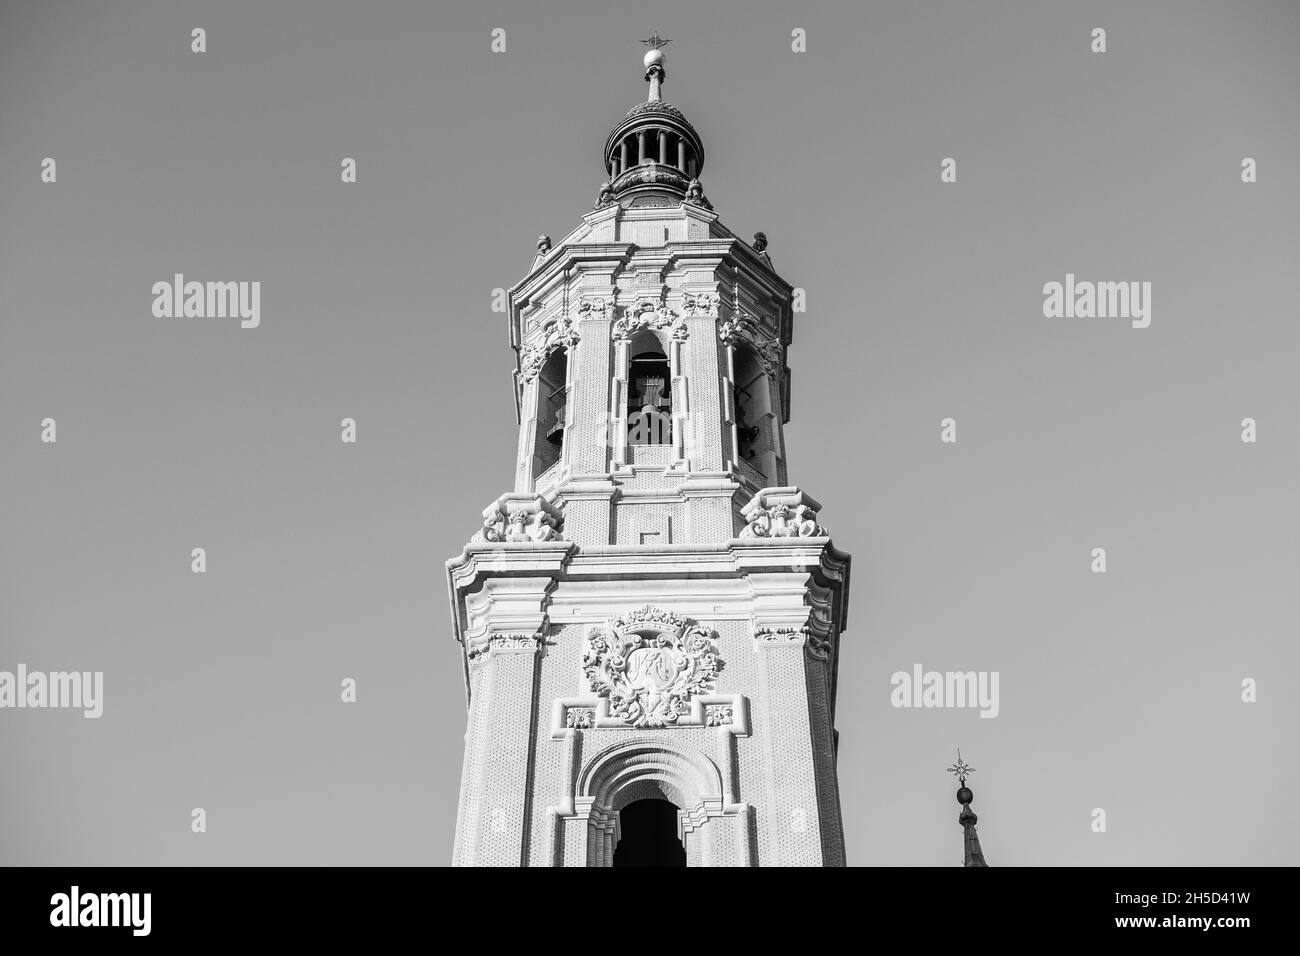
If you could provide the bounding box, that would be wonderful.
[582,605,722,727]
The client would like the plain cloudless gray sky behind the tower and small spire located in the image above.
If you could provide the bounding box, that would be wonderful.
[0,0,1300,866]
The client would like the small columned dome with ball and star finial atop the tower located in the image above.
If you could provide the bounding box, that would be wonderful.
[605,34,705,206]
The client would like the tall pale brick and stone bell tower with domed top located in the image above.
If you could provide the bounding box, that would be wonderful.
[447,35,849,866]
